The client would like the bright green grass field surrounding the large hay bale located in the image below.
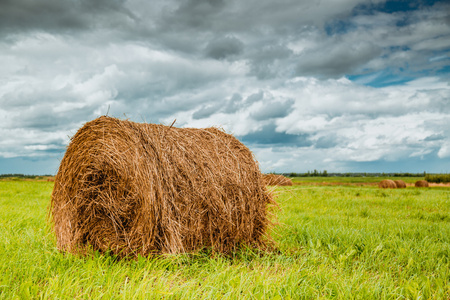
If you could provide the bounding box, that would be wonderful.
[0,179,450,299]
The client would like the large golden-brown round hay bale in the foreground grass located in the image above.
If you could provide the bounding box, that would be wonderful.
[50,116,274,256]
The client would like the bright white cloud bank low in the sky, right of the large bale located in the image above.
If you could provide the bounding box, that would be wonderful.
[162,74,450,170]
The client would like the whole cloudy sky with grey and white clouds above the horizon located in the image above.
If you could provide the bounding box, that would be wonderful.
[0,0,450,174]
